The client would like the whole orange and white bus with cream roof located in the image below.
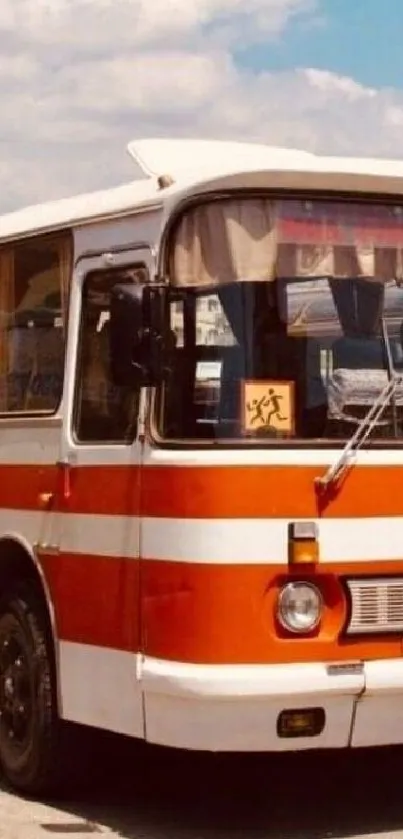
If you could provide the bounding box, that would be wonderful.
[0,140,403,794]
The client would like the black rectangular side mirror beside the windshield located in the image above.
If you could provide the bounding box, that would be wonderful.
[110,283,168,385]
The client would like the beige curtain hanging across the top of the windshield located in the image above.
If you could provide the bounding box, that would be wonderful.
[170,197,403,286]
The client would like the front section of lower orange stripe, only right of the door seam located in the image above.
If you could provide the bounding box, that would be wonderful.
[142,562,403,664]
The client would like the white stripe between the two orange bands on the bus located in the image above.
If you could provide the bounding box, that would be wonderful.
[0,510,403,564]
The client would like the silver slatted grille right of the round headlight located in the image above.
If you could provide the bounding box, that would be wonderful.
[347,577,403,635]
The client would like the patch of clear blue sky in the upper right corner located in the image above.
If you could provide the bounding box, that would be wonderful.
[237,0,403,88]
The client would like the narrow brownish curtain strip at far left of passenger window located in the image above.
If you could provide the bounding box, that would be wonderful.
[0,248,15,413]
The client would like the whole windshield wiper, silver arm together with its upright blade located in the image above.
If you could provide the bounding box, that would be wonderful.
[315,318,403,490]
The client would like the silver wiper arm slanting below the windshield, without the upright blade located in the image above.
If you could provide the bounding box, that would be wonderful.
[315,369,403,489]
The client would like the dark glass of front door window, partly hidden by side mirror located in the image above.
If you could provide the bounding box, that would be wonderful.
[74,265,147,444]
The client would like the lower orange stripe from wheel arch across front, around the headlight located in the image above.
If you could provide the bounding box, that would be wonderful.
[41,554,403,664]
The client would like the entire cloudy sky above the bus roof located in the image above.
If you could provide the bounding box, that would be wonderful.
[0,0,403,217]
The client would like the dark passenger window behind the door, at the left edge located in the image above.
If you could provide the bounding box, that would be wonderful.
[0,236,71,414]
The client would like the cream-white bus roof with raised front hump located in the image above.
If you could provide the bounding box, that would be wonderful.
[0,139,403,243]
